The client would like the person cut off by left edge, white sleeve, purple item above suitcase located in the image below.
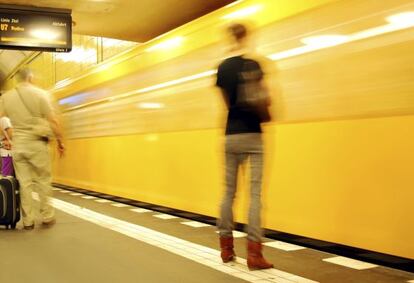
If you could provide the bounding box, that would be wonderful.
[0,117,14,176]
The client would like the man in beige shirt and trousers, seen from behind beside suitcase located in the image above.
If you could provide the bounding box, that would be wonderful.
[0,68,65,230]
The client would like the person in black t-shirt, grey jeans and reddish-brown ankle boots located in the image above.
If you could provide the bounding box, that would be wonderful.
[216,24,273,270]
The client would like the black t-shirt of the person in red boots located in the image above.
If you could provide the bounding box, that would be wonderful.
[216,56,262,135]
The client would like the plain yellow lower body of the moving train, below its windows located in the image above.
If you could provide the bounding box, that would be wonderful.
[54,116,414,258]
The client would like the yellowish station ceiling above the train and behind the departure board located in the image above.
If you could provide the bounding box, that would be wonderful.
[0,0,235,42]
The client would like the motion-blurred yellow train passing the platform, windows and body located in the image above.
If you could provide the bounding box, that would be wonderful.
[53,0,414,258]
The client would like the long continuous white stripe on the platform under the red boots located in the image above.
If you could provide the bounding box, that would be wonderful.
[41,194,318,283]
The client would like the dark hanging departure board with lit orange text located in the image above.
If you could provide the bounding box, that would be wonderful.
[0,5,72,52]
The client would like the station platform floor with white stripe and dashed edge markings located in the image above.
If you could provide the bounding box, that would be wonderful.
[0,189,414,283]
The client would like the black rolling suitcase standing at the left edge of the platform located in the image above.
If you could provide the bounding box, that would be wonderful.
[0,176,20,229]
